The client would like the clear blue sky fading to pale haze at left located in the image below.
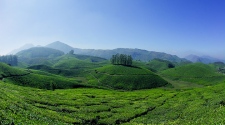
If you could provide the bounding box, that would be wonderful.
[0,0,225,59]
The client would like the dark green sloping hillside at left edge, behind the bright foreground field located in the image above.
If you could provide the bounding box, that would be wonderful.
[0,63,91,89]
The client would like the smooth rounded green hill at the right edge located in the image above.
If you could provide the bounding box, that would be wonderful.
[161,63,225,85]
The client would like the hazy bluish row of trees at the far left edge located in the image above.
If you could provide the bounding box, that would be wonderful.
[0,55,18,66]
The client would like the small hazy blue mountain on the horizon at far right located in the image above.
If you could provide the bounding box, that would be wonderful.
[185,55,224,64]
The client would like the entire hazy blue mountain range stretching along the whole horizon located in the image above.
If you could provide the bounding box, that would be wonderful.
[10,41,225,64]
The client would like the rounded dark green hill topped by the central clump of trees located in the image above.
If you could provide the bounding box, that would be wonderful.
[87,65,168,90]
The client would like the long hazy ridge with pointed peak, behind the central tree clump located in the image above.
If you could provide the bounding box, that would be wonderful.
[46,41,187,63]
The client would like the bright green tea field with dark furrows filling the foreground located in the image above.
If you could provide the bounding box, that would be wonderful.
[0,81,225,125]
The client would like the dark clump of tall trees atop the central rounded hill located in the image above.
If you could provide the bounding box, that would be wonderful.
[111,54,133,66]
